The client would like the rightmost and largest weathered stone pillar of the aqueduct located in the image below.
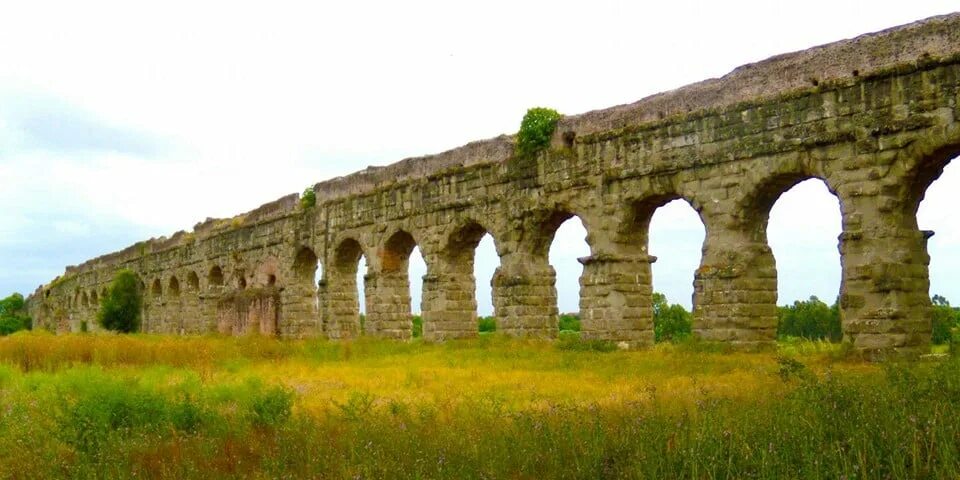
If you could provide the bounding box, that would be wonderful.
[840,197,933,355]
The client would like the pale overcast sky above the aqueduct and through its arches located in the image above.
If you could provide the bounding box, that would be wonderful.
[0,0,960,313]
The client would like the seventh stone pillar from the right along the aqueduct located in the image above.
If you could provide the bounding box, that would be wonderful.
[319,269,369,340]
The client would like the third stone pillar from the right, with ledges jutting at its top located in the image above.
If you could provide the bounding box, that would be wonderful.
[579,254,656,347]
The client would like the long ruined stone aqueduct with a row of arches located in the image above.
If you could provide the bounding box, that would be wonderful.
[29,14,960,351]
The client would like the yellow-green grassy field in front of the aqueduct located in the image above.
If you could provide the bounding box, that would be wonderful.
[0,333,960,479]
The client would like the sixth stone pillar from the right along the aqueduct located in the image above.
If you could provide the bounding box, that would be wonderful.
[366,268,413,340]
